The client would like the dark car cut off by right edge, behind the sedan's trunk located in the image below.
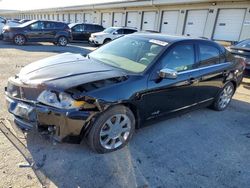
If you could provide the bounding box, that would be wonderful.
[229,39,250,71]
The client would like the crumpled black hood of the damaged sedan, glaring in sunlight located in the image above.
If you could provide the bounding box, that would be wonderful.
[18,53,125,90]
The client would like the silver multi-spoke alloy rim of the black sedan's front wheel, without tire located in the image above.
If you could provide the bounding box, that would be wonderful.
[100,114,131,149]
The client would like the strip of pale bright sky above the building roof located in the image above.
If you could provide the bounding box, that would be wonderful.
[0,0,119,10]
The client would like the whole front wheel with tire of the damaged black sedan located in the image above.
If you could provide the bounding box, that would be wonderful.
[87,105,135,153]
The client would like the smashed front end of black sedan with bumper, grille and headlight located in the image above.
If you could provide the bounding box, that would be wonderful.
[5,77,126,141]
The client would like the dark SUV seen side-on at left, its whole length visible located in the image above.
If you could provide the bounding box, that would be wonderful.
[3,20,72,46]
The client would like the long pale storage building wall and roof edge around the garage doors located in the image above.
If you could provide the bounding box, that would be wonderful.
[2,0,250,40]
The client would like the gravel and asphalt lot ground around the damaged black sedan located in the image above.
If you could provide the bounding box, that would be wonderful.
[0,41,250,188]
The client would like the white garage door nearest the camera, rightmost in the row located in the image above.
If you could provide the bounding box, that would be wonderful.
[213,9,246,41]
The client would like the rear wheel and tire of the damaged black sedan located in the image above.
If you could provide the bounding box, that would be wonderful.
[212,82,235,111]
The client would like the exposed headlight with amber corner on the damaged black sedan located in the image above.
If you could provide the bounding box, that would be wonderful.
[37,90,86,109]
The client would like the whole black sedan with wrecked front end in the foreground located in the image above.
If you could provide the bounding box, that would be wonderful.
[6,34,244,153]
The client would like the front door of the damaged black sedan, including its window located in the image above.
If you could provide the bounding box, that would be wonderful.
[142,43,199,119]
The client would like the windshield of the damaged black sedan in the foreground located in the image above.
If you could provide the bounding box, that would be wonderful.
[89,36,167,73]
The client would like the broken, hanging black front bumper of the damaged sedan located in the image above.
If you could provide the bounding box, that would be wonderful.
[6,93,93,141]
